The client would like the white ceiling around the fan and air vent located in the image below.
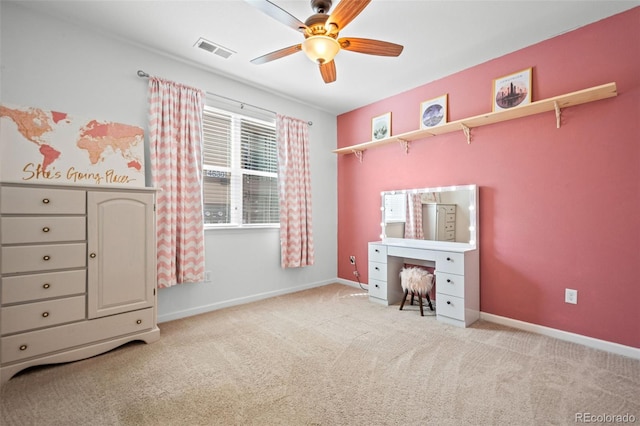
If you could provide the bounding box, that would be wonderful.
[11,0,640,114]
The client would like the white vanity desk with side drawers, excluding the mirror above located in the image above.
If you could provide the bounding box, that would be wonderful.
[369,241,480,327]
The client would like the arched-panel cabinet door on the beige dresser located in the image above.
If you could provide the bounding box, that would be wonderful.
[87,191,156,318]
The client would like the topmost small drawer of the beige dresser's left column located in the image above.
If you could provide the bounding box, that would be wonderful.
[0,186,86,214]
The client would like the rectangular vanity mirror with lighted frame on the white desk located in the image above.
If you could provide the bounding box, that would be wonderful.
[380,185,478,247]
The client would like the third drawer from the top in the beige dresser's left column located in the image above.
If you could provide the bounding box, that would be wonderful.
[2,243,87,274]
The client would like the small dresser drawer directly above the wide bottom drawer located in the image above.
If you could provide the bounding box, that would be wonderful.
[0,296,86,335]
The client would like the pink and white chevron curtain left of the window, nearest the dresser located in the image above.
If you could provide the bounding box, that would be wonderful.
[149,77,204,288]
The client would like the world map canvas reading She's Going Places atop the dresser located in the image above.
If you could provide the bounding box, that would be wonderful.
[0,104,145,187]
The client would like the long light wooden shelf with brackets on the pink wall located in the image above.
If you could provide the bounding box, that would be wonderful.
[333,82,618,161]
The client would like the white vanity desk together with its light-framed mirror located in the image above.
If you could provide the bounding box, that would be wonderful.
[368,185,480,327]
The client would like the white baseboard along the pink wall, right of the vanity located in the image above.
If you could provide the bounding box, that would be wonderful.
[480,312,640,359]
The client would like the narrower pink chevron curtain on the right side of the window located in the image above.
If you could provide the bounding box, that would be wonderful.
[276,114,314,268]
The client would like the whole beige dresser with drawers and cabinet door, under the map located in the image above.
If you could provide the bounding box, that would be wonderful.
[0,183,160,382]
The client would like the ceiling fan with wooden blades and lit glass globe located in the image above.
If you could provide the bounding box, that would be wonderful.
[245,0,403,83]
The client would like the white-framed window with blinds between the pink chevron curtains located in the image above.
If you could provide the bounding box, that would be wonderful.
[203,106,280,227]
